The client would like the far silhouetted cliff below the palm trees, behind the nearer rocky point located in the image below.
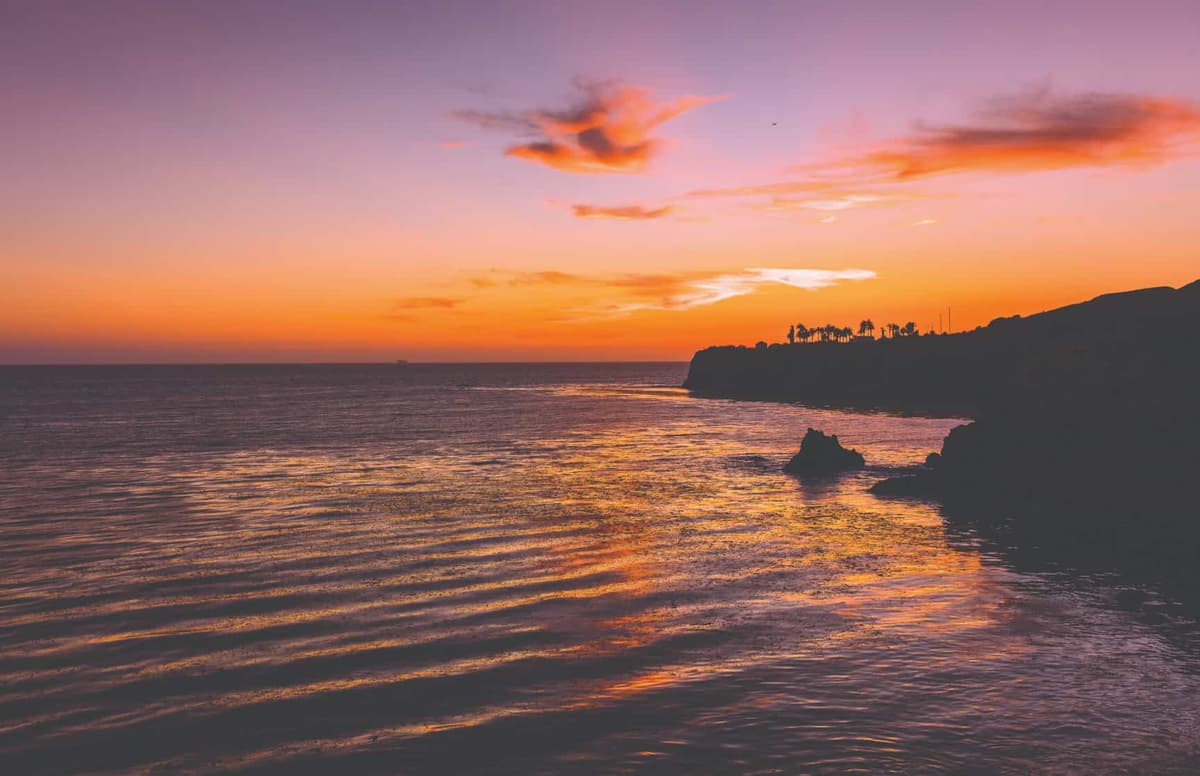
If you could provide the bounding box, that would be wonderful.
[684,275,1200,415]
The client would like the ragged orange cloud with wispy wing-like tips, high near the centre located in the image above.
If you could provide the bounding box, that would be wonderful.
[454,82,724,173]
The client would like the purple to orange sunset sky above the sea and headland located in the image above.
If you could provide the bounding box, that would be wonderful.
[0,0,1200,363]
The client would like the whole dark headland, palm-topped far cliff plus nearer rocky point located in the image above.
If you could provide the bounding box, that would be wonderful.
[684,281,1200,575]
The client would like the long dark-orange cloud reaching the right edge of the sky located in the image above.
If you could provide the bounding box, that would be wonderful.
[826,89,1200,181]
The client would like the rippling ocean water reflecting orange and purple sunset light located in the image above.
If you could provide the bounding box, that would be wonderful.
[0,365,1200,774]
